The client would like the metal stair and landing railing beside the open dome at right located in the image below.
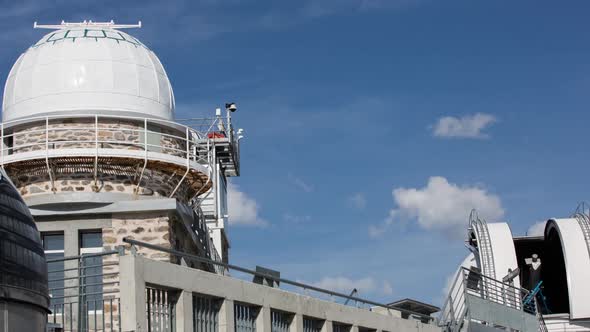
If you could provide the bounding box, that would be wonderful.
[439,268,537,331]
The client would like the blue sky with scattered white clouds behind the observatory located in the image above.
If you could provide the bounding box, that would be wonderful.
[0,0,590,303]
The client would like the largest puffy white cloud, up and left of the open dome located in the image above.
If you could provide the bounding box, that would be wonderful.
[369,176,504,237]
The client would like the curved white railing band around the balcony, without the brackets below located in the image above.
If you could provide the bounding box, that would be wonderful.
[0,114,216,169]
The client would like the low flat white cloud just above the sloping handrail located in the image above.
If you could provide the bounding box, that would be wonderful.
[311,276,393,295]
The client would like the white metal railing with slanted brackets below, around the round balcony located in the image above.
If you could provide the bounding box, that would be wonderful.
[0,114,217,180]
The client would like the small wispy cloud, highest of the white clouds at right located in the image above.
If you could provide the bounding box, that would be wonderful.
[432,113,498,138]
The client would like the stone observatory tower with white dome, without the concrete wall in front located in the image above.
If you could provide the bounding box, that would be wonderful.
[0,21,239,330]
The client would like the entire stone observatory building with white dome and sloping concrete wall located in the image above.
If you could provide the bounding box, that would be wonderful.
[0,22,439,332]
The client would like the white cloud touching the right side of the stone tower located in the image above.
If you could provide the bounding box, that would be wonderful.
[227,183,268,227]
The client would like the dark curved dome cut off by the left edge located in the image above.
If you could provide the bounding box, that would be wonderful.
[0,172,49,310]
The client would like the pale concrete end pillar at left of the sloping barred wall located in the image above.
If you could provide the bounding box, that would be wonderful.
[119,254,147,332]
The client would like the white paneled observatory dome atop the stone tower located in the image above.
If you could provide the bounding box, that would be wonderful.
[2,27,174,122]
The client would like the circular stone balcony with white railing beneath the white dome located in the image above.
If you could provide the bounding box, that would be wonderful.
[0,115,215,201]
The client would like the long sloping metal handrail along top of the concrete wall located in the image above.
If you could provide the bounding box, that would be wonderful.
[123,237,434,321]
